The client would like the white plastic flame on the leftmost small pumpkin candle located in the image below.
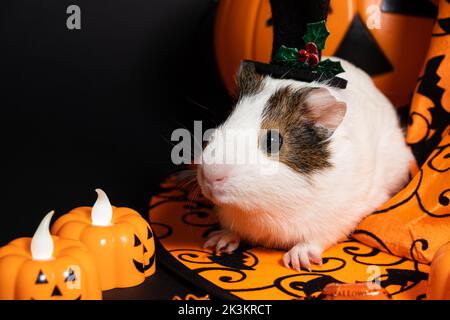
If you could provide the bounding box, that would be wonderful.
[31,210,55,260]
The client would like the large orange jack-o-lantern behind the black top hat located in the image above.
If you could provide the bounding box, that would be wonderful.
[214,0,437,107]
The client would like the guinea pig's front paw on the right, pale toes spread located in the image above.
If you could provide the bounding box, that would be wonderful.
[283,243,322,271]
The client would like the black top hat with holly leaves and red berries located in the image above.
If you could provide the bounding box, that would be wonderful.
[247,0,347,89]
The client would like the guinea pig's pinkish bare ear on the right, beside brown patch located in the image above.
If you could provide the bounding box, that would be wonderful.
[305,88,347,133]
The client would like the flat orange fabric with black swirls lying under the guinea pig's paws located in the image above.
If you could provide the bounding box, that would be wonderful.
[149,180,429,299]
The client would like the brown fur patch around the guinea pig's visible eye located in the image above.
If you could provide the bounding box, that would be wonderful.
[261,87,331,174]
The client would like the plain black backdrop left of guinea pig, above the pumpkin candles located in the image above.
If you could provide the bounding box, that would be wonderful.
[0,0,229,246]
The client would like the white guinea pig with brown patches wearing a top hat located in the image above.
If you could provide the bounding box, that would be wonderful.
[197,58,413,271]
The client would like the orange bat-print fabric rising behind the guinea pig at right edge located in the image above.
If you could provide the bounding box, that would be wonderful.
[354,0,450,263]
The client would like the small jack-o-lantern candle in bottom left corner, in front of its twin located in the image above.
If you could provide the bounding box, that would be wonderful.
[0,211,102,300]
